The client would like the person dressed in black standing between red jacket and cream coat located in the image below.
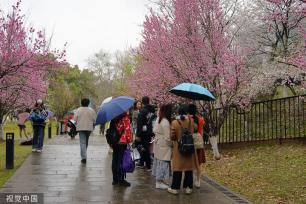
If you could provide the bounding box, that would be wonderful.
[136,96,155,170]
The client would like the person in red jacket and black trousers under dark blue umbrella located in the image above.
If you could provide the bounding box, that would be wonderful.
[110,113,133,186]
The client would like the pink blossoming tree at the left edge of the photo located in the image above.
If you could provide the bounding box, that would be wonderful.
[0,0,65,139]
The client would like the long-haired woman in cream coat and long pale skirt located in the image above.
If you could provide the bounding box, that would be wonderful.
[152,104,172,189]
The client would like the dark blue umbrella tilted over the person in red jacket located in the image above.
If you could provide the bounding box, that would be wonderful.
[96,96,135,124]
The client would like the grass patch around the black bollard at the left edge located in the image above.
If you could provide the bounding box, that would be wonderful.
[0,141,32,188]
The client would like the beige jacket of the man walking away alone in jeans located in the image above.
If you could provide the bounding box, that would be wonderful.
[73,107,96,131]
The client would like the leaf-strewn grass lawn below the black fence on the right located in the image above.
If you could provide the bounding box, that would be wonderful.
[203,142,306,203]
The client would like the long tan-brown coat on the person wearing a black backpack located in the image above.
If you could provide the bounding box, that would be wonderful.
[171,118,198,171]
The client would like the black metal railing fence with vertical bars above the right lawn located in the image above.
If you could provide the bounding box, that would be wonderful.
[215,95,306,143]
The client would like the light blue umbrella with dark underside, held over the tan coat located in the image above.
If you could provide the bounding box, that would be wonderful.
[170,83,216,101]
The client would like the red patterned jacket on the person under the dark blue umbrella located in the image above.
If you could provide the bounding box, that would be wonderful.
[116,114,133,144]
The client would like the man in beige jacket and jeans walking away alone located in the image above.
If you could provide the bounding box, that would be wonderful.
[74,98,96,164]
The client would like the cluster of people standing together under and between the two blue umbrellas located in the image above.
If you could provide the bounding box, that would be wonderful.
[106,96,205,194]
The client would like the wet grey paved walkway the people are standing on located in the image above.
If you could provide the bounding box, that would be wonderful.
[0,133,244,204]
